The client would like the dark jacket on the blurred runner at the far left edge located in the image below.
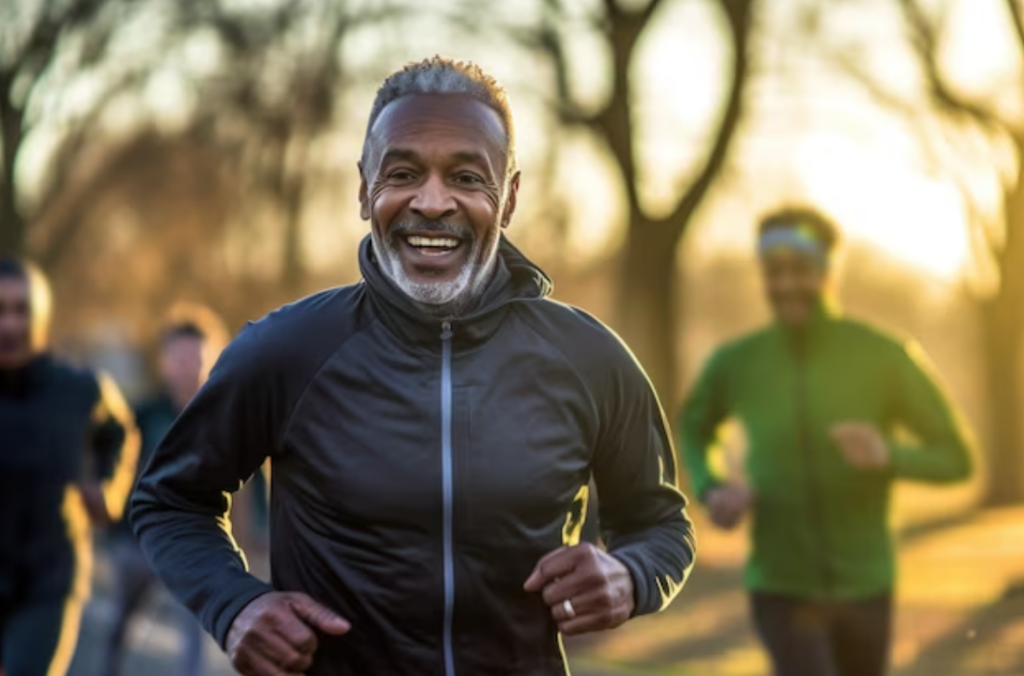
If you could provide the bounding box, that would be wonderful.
[0,354,138,605]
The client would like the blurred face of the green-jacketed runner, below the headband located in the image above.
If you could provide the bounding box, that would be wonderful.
[761,249,826,327]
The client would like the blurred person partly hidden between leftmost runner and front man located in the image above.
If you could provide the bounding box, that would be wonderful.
[101,304,226,676]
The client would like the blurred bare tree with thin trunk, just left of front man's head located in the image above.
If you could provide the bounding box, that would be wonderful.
[164,0,403,295]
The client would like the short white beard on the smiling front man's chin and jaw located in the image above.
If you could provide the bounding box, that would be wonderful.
[371,224,501,316]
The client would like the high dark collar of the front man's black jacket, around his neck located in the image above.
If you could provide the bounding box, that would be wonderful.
[359,236,553,348]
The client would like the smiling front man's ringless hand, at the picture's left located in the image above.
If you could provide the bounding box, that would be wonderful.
[227,592,351,676]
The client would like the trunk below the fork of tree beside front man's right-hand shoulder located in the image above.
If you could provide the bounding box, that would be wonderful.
[617,214,679,411]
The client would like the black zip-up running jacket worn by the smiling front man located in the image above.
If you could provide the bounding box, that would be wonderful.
[131,234,694,676]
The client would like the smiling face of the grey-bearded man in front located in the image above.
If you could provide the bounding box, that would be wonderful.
[359,94,518,313]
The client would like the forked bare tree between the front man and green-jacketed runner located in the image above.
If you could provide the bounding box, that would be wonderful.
[452,0,756,406]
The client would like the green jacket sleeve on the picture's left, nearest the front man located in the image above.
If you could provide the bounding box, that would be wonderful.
[677,350,729,501]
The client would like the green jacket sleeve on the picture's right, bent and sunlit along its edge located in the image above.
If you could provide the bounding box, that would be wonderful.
[892,344,972,483]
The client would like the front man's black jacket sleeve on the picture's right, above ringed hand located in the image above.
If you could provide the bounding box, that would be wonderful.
[594,350,696,616]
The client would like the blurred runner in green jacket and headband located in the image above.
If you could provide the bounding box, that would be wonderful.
[678,210,972,676]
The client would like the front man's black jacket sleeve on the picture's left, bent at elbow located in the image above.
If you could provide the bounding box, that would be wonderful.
[131,325,292,646]
